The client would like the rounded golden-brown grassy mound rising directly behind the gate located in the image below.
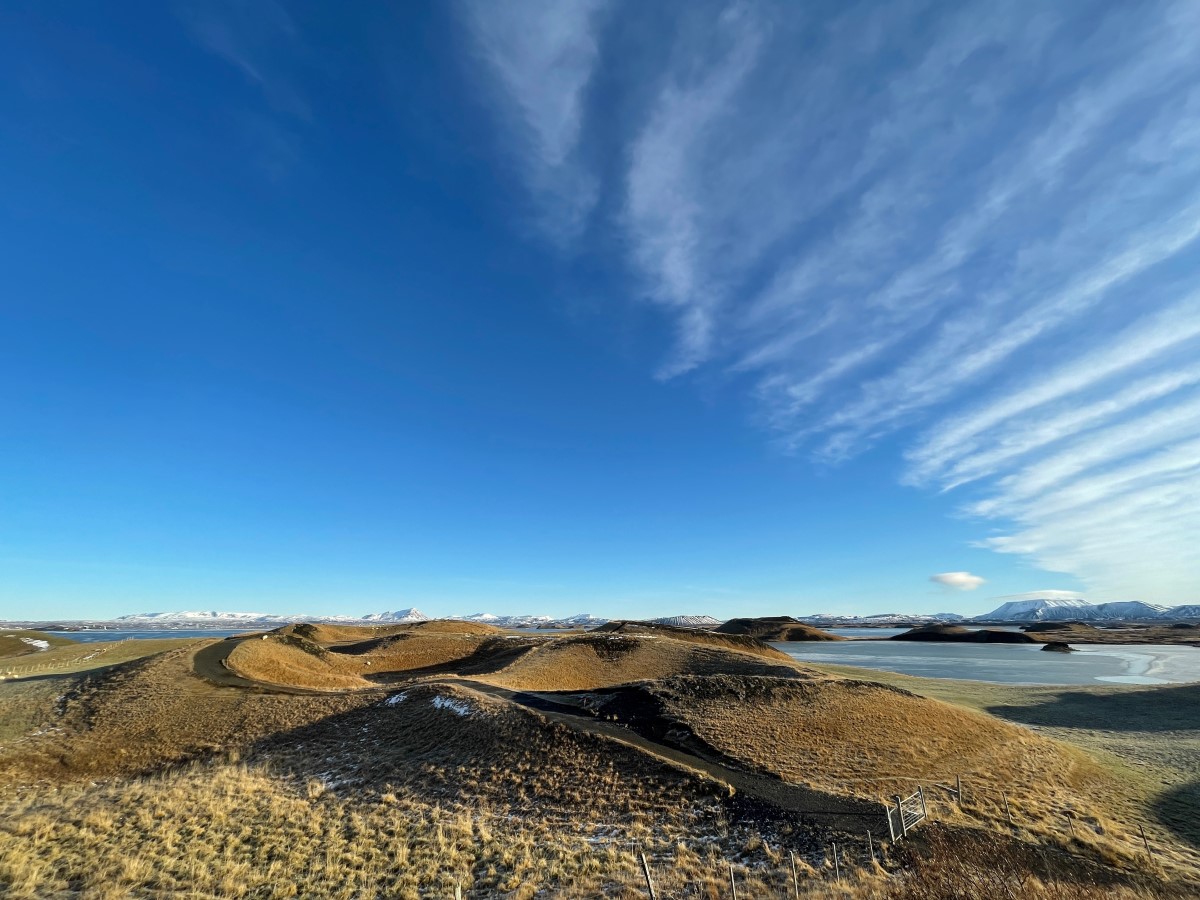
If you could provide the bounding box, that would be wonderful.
[599,676,1111,805]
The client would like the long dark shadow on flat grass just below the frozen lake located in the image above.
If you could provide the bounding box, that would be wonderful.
[988,684,1200,732]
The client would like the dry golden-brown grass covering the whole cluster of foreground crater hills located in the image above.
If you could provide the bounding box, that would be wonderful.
[0,626,1196,900]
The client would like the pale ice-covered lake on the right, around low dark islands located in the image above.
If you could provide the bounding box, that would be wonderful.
[772,629,1200,685]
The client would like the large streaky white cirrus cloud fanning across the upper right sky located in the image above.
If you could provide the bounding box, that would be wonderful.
[463,0,1200,600]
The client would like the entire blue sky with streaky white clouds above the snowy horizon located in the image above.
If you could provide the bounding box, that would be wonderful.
[0,0,1200,618]
